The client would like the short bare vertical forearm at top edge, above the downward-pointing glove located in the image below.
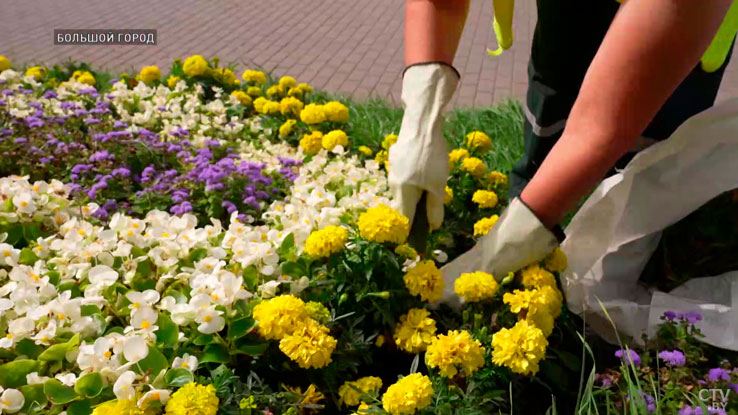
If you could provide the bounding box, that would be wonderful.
[405,0,470,66]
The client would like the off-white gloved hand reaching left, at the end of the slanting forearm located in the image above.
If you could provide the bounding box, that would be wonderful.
[441,198,563,309]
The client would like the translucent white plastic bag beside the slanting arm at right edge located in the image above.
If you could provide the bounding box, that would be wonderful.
[562,99,738,350]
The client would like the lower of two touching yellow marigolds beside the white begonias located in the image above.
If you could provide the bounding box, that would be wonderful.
[279,319,337,369]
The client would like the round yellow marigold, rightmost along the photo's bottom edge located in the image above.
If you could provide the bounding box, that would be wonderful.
[382,373,434,415]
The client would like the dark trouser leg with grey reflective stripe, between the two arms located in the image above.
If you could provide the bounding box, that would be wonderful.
[510,0,619,197]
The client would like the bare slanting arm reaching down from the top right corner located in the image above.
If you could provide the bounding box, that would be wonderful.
[521,0,731,227]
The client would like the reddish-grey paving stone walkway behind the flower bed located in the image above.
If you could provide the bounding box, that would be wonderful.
[0,0,738,106]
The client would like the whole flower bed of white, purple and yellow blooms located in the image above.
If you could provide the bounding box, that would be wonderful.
[0,56,732,415]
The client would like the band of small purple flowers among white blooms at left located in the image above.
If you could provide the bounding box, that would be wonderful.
[0,82,302,223]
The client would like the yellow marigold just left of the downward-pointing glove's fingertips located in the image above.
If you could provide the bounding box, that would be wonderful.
[359,204,410,244]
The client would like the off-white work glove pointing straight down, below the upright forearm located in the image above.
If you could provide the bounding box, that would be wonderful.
[388,62,459,229]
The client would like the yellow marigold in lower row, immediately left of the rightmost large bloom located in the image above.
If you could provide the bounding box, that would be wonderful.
[425,330,484,378]
